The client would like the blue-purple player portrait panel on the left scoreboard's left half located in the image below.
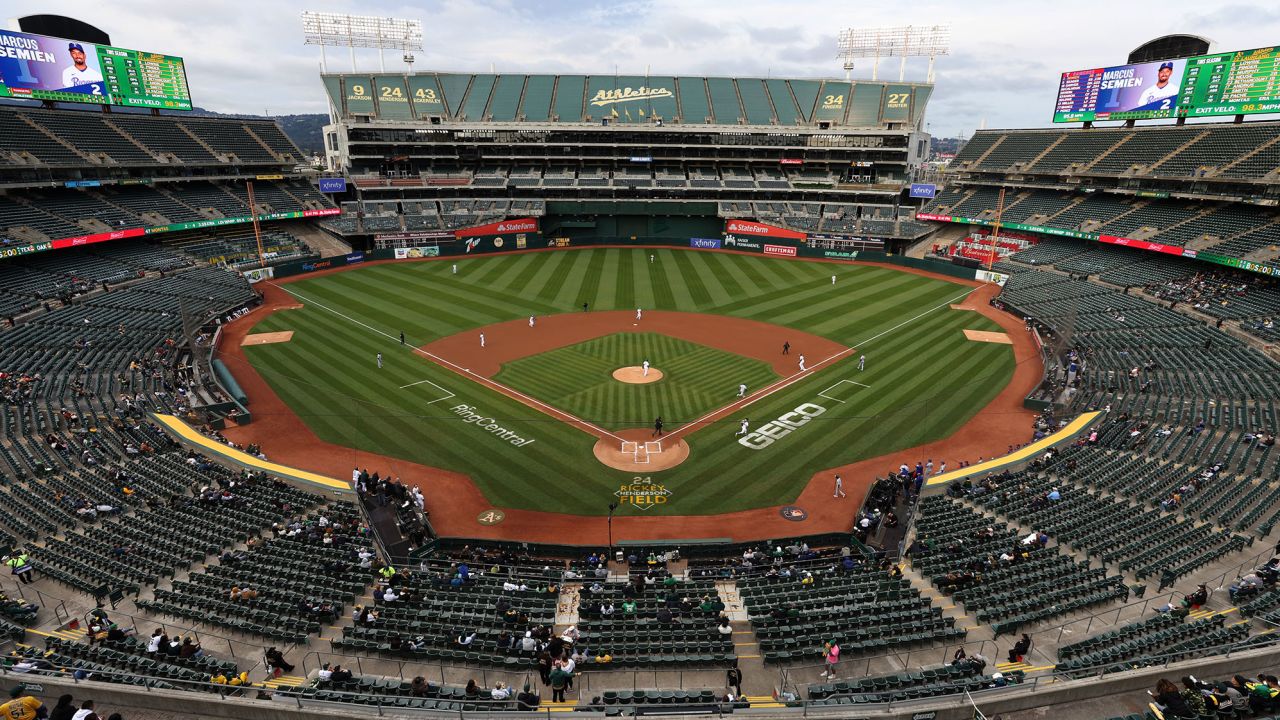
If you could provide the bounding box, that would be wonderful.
[0,31,108,102]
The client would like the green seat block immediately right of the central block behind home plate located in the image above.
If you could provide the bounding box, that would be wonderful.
[737,559,965,662]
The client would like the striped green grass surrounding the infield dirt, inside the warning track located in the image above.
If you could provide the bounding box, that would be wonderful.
[244,249,1014,515]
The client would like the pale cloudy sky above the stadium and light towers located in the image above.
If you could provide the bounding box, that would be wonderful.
[4,0,1280,137]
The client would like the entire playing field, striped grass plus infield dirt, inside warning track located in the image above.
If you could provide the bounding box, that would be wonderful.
[233,249,1015,515]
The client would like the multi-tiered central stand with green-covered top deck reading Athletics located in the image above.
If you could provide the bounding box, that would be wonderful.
[314,73,933,247]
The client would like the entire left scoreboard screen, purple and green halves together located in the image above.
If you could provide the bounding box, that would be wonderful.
[0,29,191,110]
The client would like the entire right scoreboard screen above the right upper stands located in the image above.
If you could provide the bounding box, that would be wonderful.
[1053,47,1280,123]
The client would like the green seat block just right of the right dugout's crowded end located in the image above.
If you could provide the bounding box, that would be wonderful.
[911,496,1129,635]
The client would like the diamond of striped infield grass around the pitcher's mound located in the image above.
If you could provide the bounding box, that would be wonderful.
[493,333,777,430]
